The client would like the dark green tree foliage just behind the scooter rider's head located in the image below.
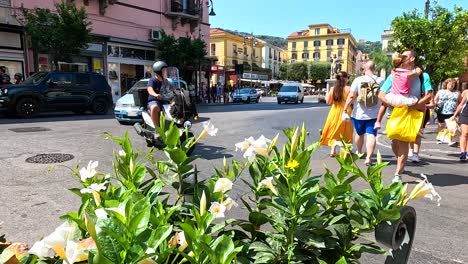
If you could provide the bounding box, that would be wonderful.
[154,32,206,79]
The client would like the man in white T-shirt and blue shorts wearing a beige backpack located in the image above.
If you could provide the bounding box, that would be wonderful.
[345,60,384,166]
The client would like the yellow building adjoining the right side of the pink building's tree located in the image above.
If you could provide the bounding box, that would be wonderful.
[208,28,264,83]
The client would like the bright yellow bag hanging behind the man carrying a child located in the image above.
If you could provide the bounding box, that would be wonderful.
[386,106,424,142]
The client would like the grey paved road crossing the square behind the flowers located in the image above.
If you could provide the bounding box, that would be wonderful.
[0,97,468,263]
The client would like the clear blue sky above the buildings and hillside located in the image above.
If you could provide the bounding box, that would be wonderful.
[210,0,467,41]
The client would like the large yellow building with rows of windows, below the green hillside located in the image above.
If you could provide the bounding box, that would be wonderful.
[288,23,357,74]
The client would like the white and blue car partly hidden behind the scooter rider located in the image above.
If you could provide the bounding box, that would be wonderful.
[114,79,187,124]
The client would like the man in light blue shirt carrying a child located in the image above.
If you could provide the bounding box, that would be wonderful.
[379,50,432,182]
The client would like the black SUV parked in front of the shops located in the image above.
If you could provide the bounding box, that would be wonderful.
[0,72,112,117]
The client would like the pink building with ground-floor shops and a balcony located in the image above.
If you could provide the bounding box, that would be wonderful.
[1,0,210,100]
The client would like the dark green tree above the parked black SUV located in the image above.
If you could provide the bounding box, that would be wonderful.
[22,2,92,69]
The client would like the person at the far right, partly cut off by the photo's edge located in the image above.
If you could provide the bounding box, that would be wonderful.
[449,86,468,161]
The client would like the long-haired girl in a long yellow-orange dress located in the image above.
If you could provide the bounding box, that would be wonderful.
[320,71,353,157]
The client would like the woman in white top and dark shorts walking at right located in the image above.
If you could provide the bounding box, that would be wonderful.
[434,78,461,146]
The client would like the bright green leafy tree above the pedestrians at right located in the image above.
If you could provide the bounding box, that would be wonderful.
[392,5,468,83]
